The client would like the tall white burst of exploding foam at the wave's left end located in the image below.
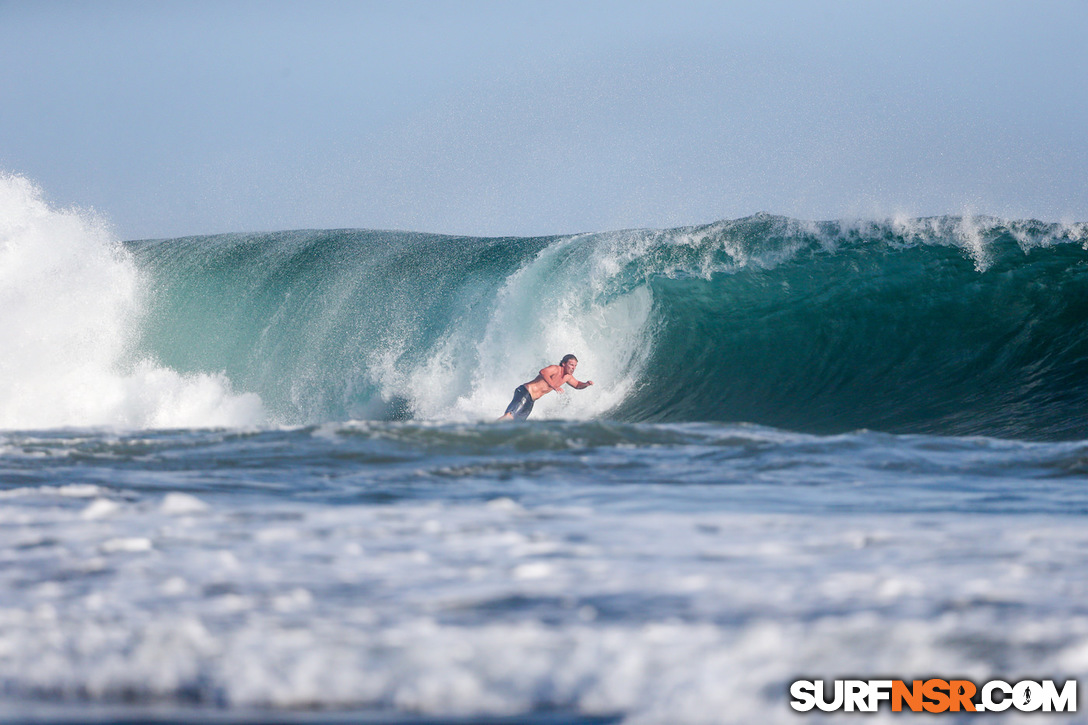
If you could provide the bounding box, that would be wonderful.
[0,175,264,429]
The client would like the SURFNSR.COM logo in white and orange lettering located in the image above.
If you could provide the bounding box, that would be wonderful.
[790,678,1077,713]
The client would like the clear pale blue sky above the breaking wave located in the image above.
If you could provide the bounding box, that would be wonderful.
[0,0,1088,238]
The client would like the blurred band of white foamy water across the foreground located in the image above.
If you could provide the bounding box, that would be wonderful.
[0,494,1088,724]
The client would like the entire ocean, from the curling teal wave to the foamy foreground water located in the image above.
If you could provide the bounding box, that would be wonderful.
[0,171,1088,725]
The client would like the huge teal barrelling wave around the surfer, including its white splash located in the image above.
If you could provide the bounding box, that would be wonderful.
[0,171,1088,440]
